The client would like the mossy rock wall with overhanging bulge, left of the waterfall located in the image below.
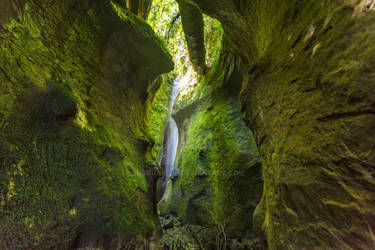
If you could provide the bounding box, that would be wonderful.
[0,0,173,249]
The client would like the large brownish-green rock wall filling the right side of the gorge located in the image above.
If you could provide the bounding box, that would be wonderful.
[188,0,375,249]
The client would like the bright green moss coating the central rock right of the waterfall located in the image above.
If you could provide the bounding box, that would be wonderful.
[180,95,260,234]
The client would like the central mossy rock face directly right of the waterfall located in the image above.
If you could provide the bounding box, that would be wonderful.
[159,52,262,249]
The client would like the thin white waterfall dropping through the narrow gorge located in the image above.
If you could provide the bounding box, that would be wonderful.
[159,78,179,200]
